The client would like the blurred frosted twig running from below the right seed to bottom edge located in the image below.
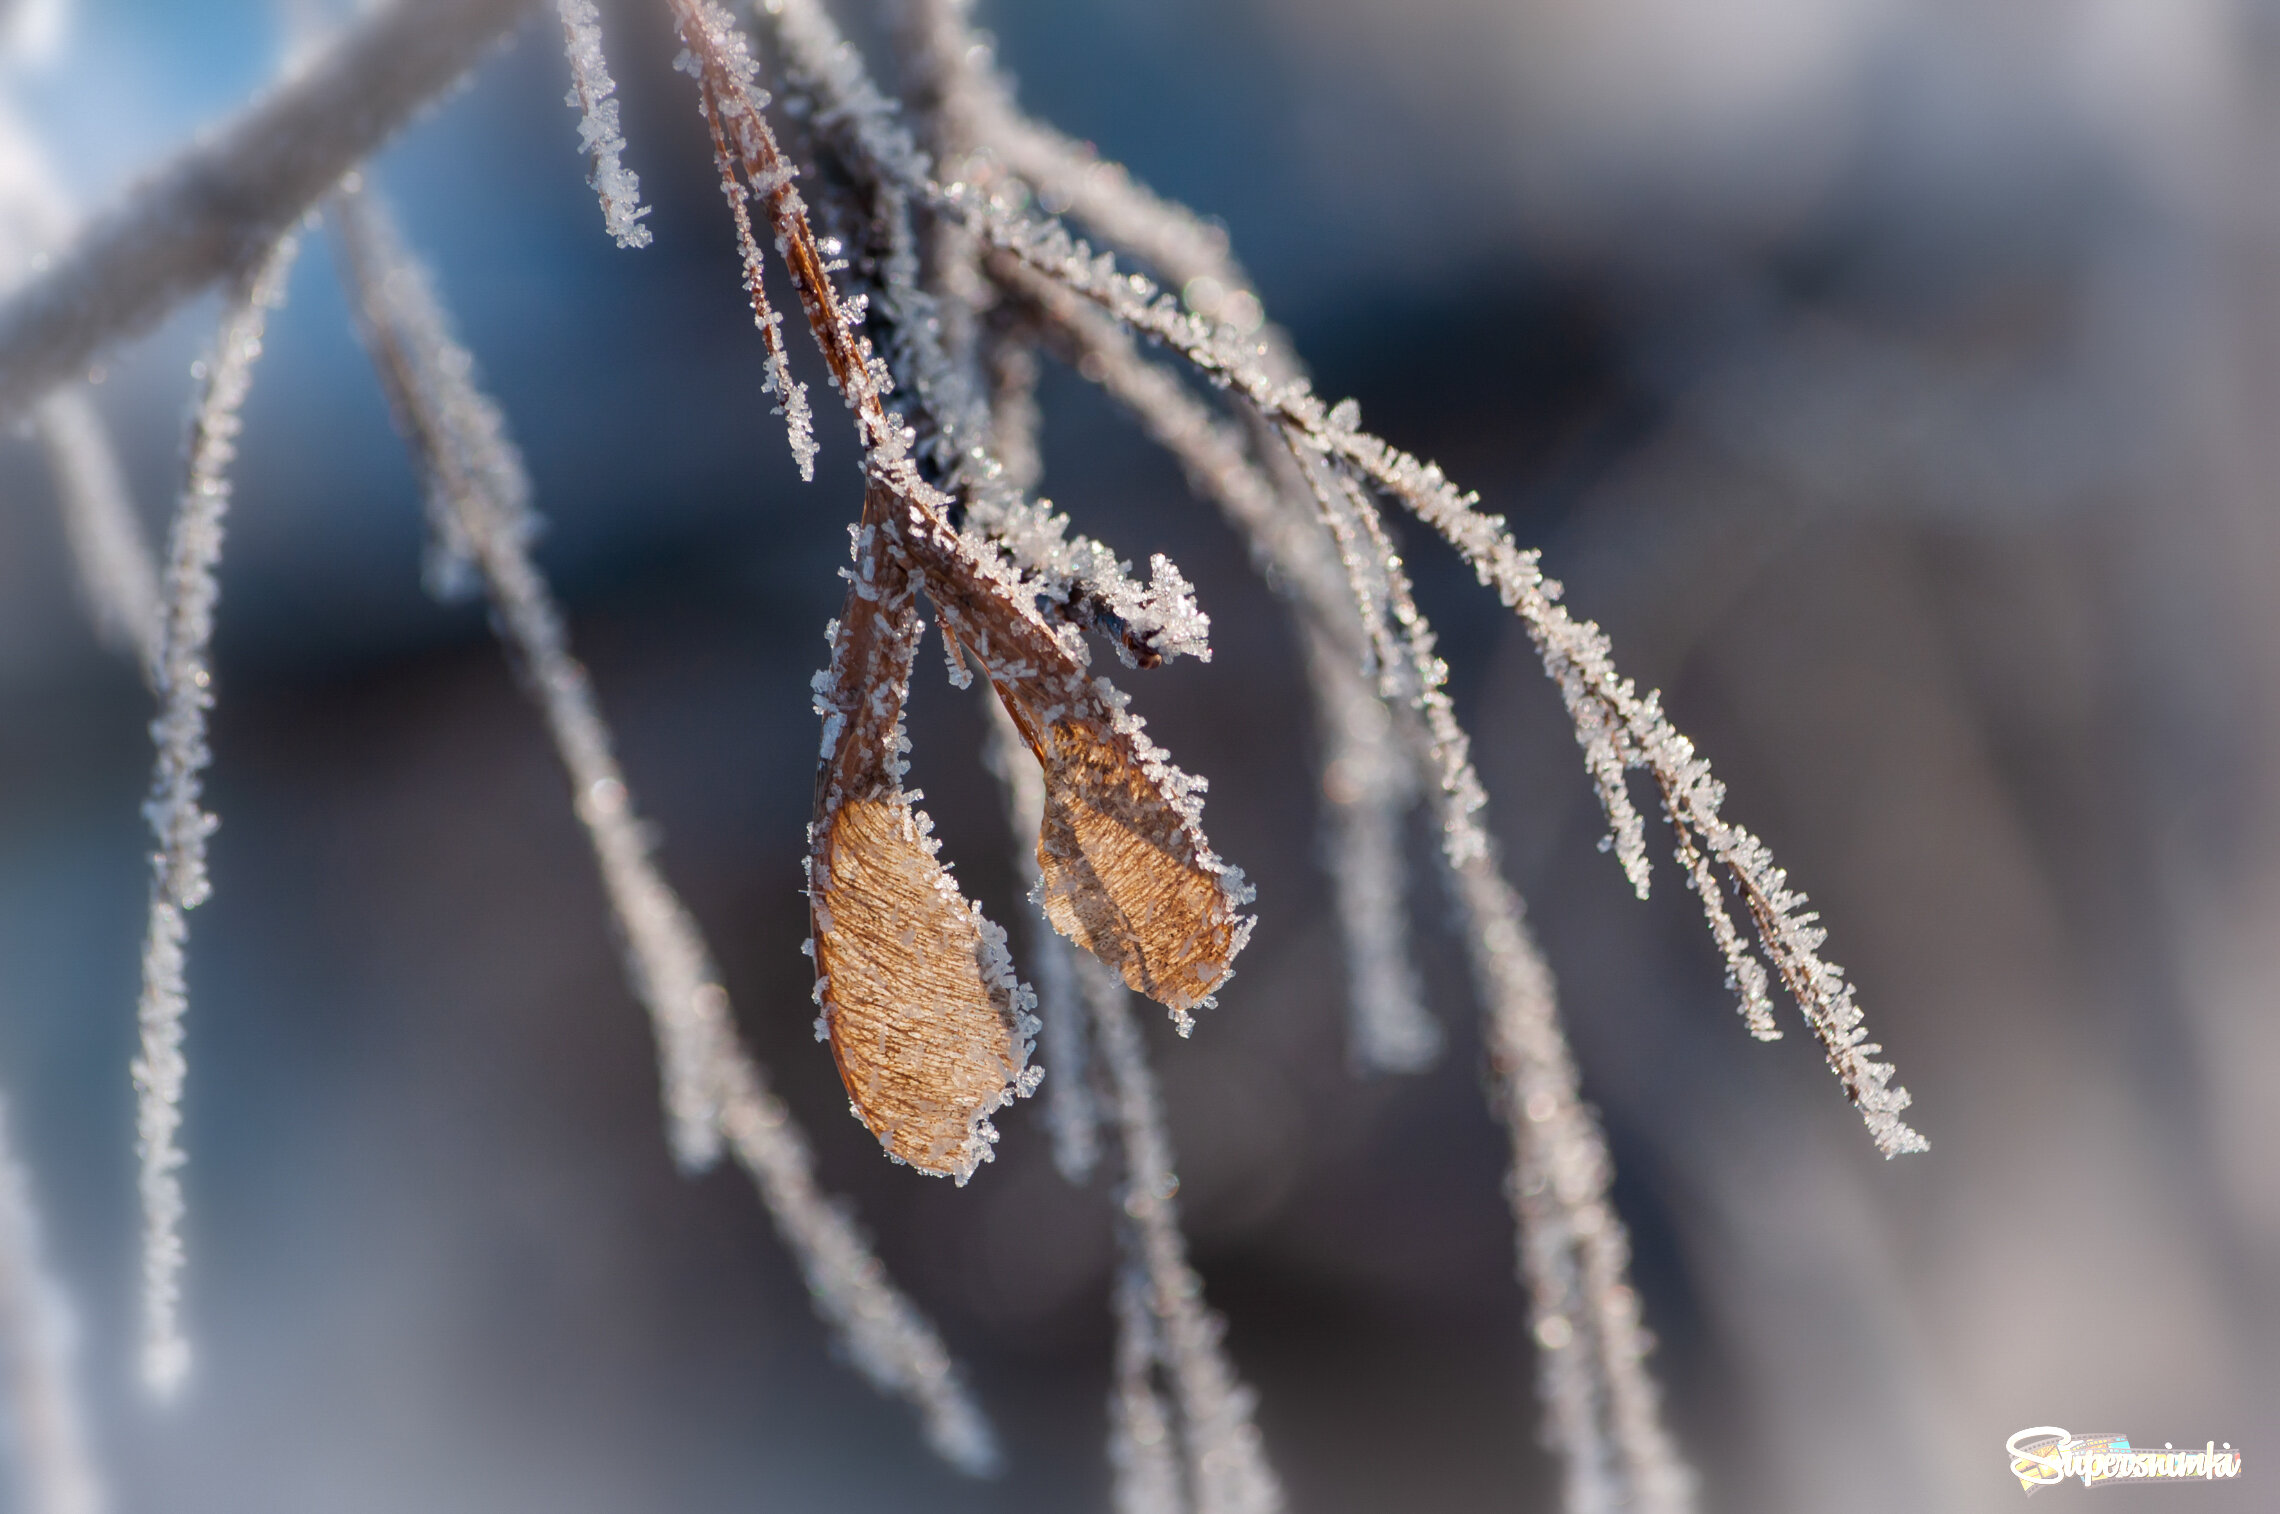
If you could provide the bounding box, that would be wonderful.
[1078,960,1284,1514]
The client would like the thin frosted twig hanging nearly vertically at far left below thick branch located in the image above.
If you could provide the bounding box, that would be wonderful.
[132,237,296,1393]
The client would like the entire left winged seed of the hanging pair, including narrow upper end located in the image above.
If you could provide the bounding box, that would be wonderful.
[807,485,1035,1183]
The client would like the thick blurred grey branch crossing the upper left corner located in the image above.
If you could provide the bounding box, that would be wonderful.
[0,0,531,417]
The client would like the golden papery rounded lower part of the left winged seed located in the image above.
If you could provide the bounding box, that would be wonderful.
[816,800,1026,1179]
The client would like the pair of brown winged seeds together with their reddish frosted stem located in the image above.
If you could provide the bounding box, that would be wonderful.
[675,0,1252,1094]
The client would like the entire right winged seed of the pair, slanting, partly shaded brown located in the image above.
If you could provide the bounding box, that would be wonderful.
[884,490,1252,1024]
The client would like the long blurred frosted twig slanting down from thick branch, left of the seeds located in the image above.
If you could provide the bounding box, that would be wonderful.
[328,189,996,1473]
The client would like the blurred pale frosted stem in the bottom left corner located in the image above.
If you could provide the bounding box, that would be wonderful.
[0,1108,105,1514]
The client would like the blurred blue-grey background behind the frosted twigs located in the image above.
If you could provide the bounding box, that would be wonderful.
[0,0,2280,1514]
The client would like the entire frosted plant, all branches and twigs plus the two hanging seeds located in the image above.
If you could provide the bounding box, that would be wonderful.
[0,0,1924,1514]
